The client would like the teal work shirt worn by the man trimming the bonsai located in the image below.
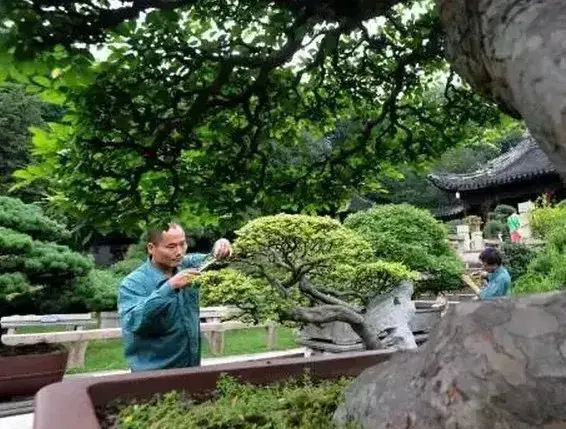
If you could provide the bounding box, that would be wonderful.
[118,253,206,371]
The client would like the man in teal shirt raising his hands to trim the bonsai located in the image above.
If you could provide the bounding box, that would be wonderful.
[118,224,232,371]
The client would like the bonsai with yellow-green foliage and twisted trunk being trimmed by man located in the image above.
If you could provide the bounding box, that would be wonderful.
[201,214,415,349]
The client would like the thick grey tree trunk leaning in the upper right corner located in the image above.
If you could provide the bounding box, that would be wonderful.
[442,0,566,180]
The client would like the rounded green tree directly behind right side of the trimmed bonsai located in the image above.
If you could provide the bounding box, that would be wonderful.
[344,204,463,292]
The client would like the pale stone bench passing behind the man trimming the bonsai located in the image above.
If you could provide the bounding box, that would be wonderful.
[1,322,277,368]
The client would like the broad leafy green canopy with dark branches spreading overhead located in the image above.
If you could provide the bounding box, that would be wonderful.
[4,0,510,237]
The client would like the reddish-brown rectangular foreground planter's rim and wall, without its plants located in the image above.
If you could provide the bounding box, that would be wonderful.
[34,350,400,429]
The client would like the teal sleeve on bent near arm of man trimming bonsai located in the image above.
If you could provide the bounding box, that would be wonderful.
[118,278,175,335]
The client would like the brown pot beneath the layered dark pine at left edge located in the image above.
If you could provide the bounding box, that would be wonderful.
[0,344,69,400]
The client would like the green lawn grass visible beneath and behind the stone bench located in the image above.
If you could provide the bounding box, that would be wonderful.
[12,326,297,374]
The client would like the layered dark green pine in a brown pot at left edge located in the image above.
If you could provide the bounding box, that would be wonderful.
[0,196,93,398]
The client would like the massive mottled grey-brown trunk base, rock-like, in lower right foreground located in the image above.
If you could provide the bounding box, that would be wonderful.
[335,292,566,429]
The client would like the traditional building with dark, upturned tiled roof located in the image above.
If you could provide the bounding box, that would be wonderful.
[428,136,566,219]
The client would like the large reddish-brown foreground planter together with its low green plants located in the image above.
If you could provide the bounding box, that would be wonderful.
[34,350,400,429]
